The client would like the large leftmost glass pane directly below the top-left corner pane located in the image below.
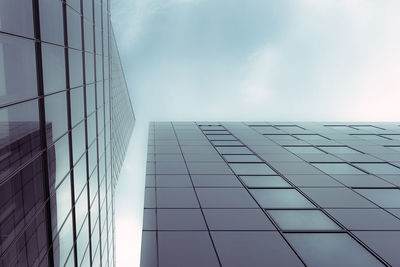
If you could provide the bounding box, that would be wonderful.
[0,34,37,105]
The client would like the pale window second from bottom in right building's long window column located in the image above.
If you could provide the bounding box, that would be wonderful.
[268,210,341,231]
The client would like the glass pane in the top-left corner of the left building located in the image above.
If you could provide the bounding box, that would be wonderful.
[0,0,33,37]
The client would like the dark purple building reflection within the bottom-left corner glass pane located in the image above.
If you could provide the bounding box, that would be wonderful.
[0,156,49,266]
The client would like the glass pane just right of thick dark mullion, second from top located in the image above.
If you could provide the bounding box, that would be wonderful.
[42,43,67,94]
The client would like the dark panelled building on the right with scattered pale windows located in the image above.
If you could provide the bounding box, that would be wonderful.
[141,122,400,267]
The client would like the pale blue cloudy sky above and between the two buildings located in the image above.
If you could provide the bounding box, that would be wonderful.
[111,0,400,266]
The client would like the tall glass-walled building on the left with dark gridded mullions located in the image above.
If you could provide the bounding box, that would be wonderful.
[0,0,135,267]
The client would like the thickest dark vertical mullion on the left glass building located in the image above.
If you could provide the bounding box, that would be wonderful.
[32,0,54,266]
